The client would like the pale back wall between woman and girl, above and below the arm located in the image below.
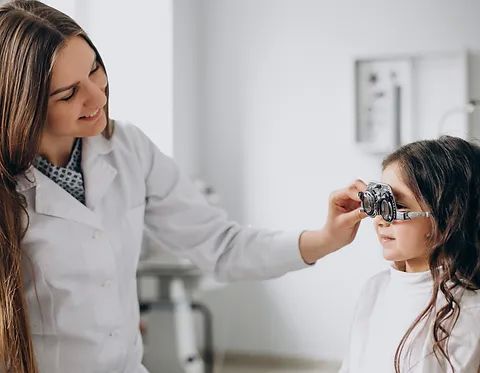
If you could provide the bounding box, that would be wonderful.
[183,0,480,359]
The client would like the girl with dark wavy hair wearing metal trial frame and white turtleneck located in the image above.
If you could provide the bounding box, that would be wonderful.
[341,137,480,373]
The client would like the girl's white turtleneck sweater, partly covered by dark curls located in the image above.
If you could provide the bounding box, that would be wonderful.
[340,267,480,373]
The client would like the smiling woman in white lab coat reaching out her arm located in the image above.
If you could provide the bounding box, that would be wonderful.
[0,0,365,373]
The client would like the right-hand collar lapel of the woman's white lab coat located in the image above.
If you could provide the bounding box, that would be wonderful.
[82,135,117,211]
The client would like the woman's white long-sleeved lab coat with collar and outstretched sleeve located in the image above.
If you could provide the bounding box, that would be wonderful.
[17,122,306,373]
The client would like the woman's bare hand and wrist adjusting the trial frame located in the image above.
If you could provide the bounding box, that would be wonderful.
[299,180,367,264]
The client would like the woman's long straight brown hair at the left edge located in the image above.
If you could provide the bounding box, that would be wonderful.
[0,0,112,373]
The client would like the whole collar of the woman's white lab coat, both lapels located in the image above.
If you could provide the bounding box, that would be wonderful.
[17,135,117,229]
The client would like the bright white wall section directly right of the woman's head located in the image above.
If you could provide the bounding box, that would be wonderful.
[75,0,173,155]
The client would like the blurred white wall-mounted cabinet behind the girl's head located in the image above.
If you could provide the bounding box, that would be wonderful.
[355,51,480,153]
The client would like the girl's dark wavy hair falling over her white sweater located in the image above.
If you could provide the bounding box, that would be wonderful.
[382,136,480,373]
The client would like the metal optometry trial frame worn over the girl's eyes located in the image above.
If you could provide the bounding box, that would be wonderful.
[358,182,432,223]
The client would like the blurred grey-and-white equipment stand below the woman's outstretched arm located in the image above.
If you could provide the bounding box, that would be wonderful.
[137,259,213,373]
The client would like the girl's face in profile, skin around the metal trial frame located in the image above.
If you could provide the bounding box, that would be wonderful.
[374,163,432,272]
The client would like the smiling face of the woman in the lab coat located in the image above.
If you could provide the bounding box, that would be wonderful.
[43,36,107,139]
